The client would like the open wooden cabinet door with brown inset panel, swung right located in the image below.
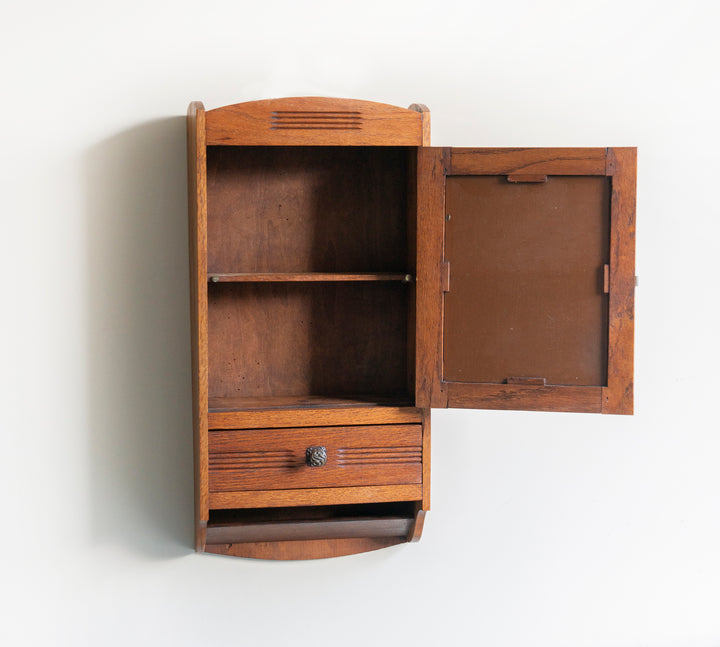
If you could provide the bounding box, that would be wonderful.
[415,147,636,414]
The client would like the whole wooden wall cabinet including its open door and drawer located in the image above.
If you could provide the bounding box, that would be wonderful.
[188,97,636,559]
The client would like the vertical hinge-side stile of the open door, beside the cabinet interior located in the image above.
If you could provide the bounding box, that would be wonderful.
[415,147,450,408]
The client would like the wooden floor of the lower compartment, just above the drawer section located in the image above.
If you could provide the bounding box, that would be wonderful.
[208,394,413,413]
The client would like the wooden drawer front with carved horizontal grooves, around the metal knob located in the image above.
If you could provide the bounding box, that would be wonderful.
[209,425,422,492]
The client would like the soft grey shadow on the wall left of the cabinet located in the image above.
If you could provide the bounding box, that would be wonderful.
[86,117,193,558]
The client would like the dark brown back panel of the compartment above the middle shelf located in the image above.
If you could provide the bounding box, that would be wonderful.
[207,146,408,273]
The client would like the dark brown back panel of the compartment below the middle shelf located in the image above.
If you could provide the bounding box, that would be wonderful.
[208,282,412,398]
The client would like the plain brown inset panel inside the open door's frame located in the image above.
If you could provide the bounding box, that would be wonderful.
[443,176,610,386]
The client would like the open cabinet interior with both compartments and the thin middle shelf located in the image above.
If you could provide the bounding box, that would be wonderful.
[207,146,414,410]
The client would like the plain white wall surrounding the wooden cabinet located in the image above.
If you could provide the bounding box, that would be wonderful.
[0,0,720,647]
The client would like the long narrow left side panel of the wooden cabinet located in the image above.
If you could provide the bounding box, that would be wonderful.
[187,102,209,551]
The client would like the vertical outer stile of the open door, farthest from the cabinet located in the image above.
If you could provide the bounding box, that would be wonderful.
[603,148,637,414]
